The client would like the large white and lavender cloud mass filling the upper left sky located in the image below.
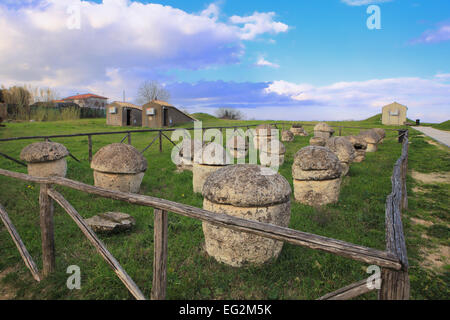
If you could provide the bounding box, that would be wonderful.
[0,0,288,99]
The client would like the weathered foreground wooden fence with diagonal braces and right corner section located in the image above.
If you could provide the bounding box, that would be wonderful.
[0,131,409,300]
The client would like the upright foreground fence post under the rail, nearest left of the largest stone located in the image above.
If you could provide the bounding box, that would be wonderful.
[151,209,168,300]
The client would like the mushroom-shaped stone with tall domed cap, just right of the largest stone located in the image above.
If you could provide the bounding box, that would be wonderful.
[292,146,342,206]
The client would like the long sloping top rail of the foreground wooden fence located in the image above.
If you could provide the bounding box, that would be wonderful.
[0,169,401,270]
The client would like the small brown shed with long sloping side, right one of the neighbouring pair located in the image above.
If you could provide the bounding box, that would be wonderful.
[142,100,196,128]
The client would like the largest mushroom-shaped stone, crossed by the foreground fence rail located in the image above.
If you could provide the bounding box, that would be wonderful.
[203,164,291,267]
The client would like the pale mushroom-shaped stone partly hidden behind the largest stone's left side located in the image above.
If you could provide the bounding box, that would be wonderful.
[192,142,232,193]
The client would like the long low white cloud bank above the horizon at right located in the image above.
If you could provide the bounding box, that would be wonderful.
[265,75,450,122]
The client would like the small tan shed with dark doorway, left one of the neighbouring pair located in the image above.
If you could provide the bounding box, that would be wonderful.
[106,101,142,127]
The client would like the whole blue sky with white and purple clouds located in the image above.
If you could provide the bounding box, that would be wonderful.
[0,0,450,122]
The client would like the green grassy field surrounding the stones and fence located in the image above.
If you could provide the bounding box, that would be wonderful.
[0,115,450,299]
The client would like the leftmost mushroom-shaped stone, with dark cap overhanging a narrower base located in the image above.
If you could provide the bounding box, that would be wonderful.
[20,142,69,177]
